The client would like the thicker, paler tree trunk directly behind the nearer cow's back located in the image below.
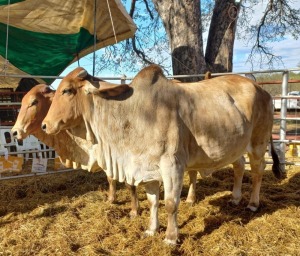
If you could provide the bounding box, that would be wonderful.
[152,0,206,81]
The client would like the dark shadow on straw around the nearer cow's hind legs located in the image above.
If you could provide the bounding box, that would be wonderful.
[181,168,300,239]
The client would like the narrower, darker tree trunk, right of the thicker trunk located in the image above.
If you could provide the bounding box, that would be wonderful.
[205,0,240,72]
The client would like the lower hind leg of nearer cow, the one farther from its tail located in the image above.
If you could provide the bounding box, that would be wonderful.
[230,156,245,205]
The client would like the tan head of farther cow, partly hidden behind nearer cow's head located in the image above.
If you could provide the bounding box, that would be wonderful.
[11,84,55,140]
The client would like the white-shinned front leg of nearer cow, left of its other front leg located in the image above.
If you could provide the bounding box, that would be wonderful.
[145,181,159,236]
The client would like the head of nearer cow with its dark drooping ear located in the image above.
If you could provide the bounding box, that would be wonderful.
[42,67,129,134]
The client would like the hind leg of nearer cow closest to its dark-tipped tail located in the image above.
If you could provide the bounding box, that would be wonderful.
[247,145,266,212]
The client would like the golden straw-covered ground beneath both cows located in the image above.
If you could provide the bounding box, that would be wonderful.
[0,163,300,256]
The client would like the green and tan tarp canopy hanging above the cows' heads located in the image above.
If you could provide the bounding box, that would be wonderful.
[0,0,136,86]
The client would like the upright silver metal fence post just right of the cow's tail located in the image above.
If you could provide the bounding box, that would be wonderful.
[279,71,289,170]
